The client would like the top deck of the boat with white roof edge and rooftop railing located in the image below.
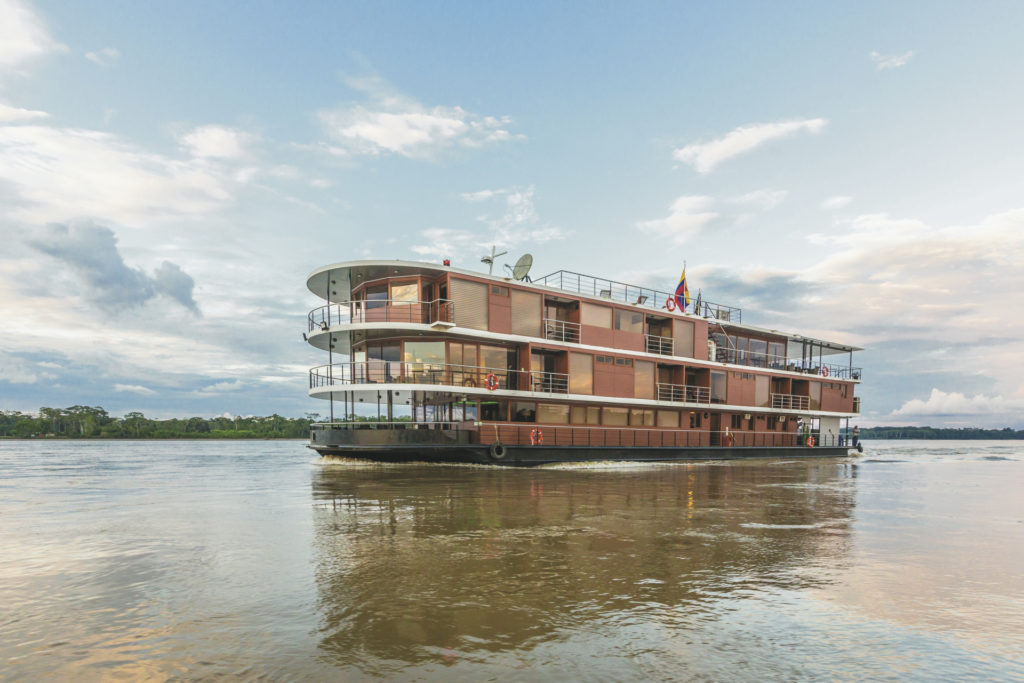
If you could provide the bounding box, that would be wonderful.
[307,260,861,381]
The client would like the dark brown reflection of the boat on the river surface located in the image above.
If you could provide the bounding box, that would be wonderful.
[312,460,856,674]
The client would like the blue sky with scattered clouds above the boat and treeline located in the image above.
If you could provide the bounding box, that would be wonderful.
[0,0,1024,428]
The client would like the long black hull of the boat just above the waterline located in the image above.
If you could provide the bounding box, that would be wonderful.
[309,443,853,467]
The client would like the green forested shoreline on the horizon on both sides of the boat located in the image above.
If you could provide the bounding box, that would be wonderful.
[0,405,1024,441]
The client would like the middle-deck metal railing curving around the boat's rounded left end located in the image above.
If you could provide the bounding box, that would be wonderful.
[309,360,569,393]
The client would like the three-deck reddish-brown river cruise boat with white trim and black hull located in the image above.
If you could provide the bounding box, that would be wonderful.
[304,260,861,466]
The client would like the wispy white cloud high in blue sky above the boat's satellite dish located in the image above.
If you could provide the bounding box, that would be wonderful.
[316,73,522,158]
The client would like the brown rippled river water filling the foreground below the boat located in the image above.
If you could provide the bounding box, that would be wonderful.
[0,441,1024,681]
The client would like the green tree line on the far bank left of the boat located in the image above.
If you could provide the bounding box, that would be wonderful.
[0,405,319,438]
